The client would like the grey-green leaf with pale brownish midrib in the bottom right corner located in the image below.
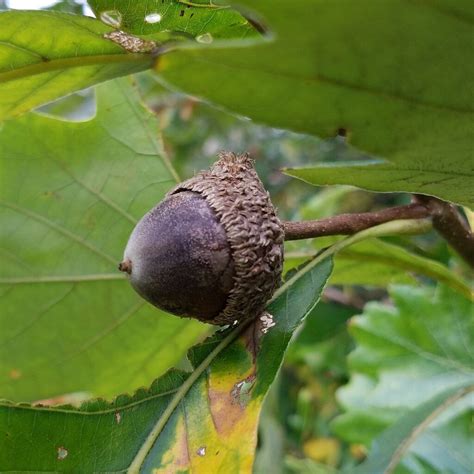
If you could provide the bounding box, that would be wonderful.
[351,387,474,474]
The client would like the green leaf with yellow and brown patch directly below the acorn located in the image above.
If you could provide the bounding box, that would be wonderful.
[0,258,332,473]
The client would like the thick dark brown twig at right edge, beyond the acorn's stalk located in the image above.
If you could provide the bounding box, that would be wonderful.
[414,195,474,267]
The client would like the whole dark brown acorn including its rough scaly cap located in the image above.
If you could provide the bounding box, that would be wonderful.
[119,152,284,324]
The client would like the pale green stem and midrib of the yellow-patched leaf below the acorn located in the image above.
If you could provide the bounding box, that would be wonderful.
[127,219,431,474]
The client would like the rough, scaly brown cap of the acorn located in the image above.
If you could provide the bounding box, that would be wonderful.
[168,152,284,324]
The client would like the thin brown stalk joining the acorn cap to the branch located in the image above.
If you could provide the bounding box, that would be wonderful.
[283,203,429,240]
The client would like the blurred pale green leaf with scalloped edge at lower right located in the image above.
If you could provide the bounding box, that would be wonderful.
[334,286,474,472]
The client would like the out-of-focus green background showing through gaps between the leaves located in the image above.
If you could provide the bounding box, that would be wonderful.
[0,0,467,474]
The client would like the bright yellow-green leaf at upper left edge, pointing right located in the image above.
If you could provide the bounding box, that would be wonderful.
[0,11,152,121]
